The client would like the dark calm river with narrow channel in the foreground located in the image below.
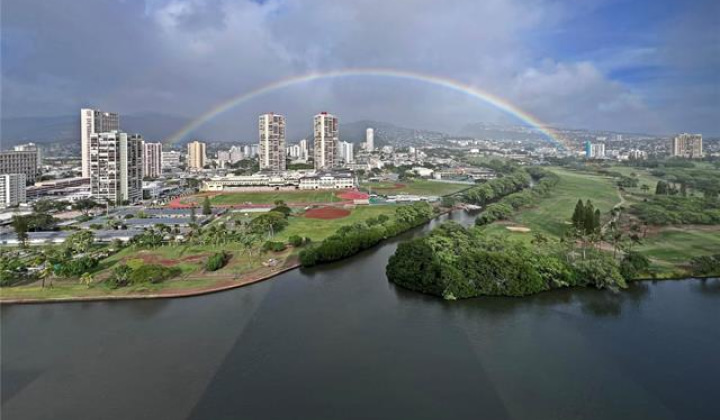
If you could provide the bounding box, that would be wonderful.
[1,214,720,420]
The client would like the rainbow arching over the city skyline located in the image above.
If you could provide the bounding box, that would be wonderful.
[164,68,565,149]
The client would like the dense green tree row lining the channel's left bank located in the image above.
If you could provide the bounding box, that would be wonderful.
[300,202,434,267]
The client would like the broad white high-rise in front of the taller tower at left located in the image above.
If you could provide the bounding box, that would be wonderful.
[90,131,143,203]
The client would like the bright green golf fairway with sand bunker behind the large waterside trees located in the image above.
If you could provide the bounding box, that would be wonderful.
[500,168,620,237]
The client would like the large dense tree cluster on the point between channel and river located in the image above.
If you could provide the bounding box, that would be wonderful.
[386,222,626,299]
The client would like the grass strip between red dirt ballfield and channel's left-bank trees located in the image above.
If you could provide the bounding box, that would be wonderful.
[274,206,396,242]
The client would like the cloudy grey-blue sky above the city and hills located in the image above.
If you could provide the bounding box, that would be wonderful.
[2,0,720,139]
